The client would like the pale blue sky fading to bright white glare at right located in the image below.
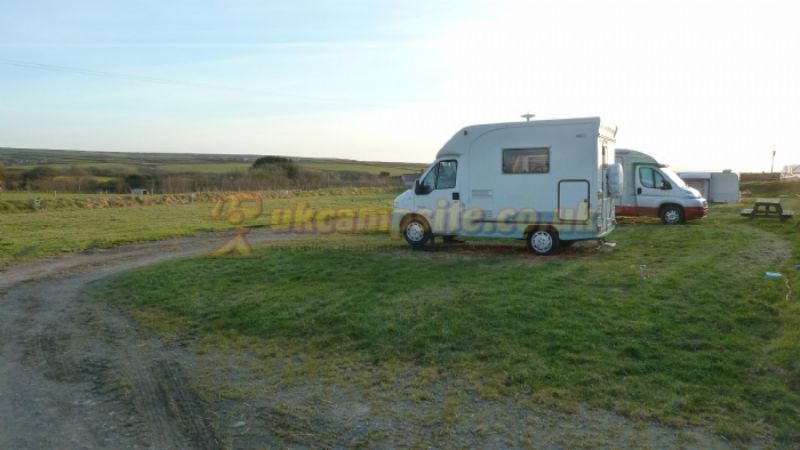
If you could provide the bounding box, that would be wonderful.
[0,0,800,171]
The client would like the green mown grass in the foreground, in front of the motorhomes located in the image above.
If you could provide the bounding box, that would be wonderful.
[97,207,800,442]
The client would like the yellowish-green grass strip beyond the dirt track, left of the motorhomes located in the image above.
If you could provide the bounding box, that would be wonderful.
[0,189,396,267]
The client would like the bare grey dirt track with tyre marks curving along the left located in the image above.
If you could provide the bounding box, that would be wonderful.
[0,230,300,449]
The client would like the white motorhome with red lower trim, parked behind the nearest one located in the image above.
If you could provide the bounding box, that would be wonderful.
[616,149,708,225]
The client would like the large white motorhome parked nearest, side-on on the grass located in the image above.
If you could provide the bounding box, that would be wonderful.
[392,118,622,255]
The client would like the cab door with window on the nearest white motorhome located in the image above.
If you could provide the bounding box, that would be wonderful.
[415,159,461,234]
